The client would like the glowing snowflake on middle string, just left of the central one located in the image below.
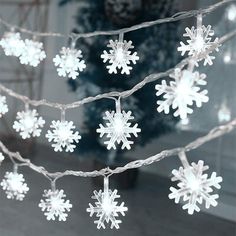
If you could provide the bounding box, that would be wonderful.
[46,120,81,152]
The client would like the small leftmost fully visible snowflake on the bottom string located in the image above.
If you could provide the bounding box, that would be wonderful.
[1,172,29,201]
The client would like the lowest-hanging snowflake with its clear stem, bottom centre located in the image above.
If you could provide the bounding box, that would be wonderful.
[87,177,128,229]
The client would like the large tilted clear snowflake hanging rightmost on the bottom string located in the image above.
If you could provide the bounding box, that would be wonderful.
[169,160,222,214]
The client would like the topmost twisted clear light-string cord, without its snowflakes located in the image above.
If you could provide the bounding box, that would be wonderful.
[0,0,235,39]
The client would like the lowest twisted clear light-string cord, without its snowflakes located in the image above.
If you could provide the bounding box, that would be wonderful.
[0,115,236,181]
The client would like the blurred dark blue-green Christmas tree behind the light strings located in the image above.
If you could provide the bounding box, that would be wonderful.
[60,0,179,160]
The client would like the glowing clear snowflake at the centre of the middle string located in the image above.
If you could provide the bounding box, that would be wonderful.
[97,111,141,150]
